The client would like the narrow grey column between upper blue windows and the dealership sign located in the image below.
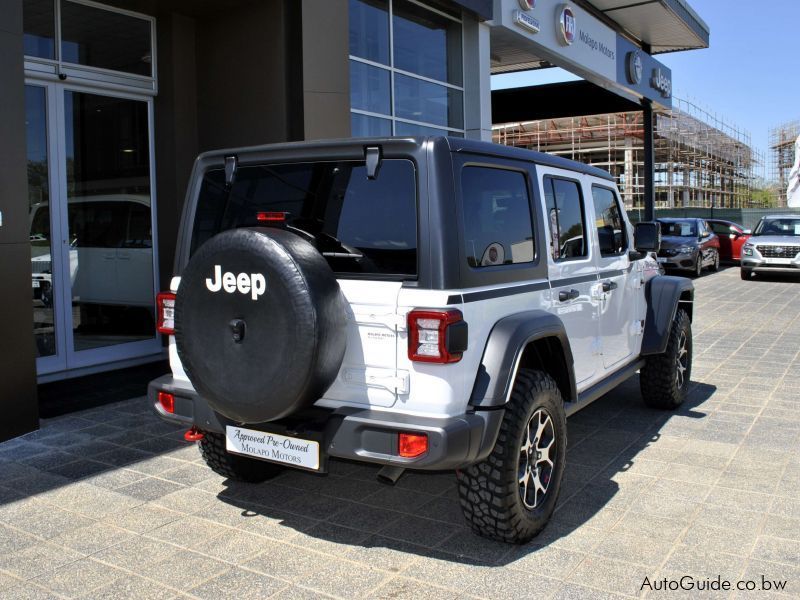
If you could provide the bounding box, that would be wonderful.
[464,15,492,142]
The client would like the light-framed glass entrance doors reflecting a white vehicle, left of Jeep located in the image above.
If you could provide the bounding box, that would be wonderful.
[26,83,161,375]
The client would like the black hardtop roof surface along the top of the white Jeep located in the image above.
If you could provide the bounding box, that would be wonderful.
[199,136,614,182]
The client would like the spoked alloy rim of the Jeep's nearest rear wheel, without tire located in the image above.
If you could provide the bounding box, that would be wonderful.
[519,408,557,510]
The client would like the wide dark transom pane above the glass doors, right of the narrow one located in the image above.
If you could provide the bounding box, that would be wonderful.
[61,0,153,76]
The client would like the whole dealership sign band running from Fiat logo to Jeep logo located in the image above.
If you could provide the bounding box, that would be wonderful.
[493,0,672,108]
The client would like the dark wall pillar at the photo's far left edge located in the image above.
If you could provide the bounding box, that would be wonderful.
[0,0,39,441]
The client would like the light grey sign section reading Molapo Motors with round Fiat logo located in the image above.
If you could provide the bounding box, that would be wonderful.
[494,0,617,81]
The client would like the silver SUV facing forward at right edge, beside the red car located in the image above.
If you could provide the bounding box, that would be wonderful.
[741,215,800,279]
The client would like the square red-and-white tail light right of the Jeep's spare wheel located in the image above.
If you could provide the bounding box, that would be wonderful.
[408,309,467,364]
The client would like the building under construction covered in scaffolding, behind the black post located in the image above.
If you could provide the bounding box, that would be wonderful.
[492,98,764,209]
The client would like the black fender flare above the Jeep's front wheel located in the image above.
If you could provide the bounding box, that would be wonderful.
[640,275,694,356]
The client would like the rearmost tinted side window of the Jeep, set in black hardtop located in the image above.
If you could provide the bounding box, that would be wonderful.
[461,167,534,267]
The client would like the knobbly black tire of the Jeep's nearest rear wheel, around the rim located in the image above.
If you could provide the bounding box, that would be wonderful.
[457,369,567,544]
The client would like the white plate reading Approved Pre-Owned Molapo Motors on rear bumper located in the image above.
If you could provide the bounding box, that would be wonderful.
[225,425,319,471]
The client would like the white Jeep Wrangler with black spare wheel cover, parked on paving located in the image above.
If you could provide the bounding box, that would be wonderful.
[149,137,693,543]
